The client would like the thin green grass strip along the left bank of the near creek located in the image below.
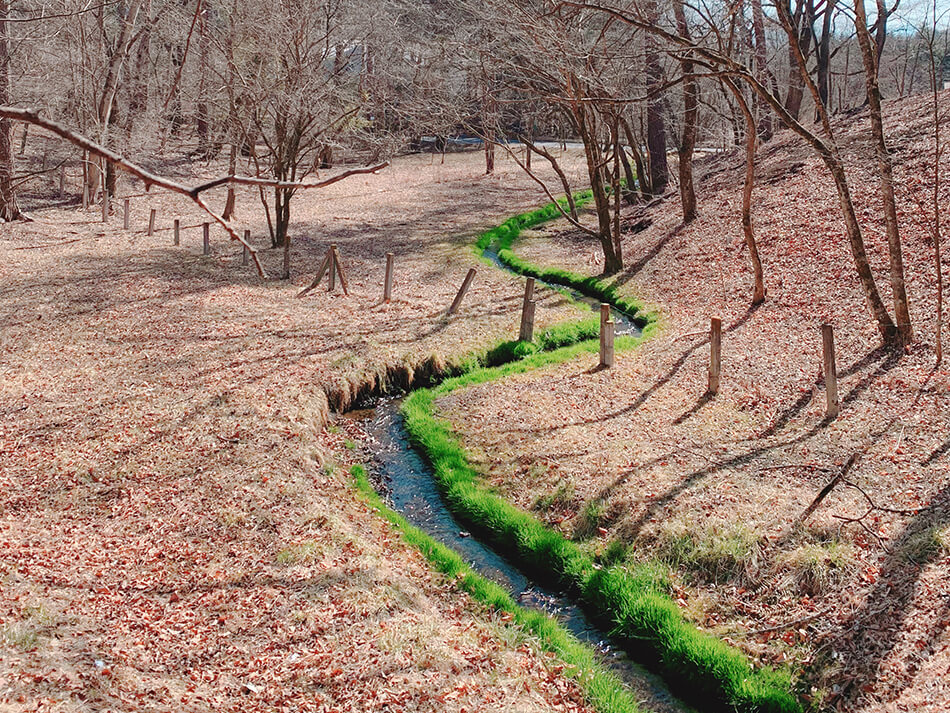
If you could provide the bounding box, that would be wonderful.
[350,465,639,713]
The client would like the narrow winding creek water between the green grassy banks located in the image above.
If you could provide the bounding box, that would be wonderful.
[345,250,693,713]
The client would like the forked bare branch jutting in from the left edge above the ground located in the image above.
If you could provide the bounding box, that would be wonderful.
[0,106,389,278]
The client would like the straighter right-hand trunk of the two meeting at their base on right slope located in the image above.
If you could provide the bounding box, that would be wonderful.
[854,0,914,344]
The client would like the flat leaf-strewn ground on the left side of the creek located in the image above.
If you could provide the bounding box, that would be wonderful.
[0,147,608,711]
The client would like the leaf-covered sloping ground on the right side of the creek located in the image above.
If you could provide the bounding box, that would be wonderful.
[440,92,950,713]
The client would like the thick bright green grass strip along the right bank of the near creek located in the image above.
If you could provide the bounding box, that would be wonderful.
[403,337,801,713]
